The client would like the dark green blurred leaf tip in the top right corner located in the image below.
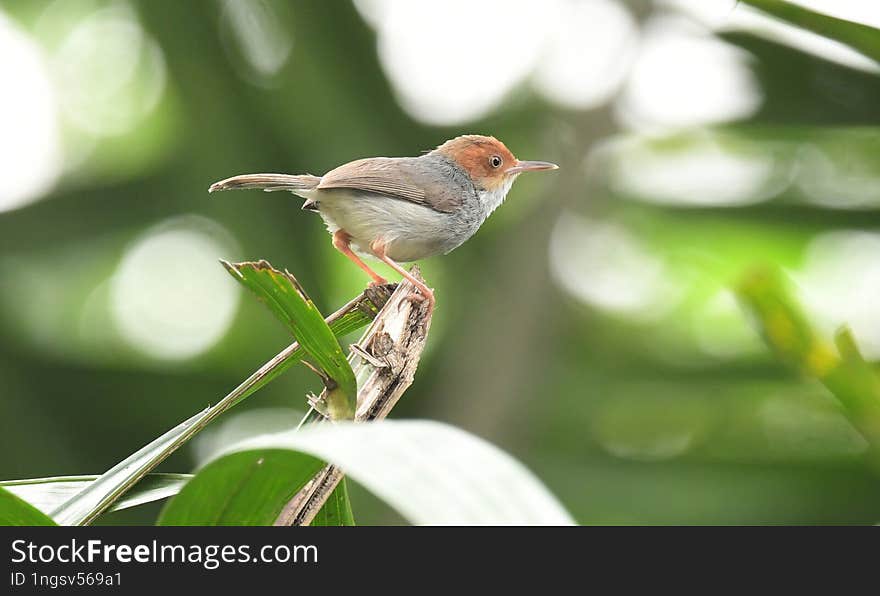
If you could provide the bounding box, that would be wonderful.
[741,0,880,62]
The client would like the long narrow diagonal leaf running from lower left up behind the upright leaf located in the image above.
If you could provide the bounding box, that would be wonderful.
[51,284,377,525]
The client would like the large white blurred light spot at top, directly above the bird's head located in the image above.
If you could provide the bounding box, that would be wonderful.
[356,0,558,125]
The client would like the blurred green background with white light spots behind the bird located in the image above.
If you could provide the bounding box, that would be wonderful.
[0,0,880,524]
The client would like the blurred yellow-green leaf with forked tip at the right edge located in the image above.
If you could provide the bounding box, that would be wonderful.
[737,268,880,464]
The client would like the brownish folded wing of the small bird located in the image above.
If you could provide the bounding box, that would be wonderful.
[317,157,461,213]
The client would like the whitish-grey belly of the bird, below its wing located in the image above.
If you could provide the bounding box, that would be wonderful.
[314,190,463,262]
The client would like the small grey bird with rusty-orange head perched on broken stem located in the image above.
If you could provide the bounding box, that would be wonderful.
[208,135,558,310]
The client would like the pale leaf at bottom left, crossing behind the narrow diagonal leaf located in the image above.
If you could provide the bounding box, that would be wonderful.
[0,474,192,515]
